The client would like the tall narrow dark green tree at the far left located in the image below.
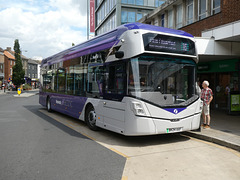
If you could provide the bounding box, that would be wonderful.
[12,39,25,87]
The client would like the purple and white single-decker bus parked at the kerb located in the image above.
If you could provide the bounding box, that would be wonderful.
[39,23,202,136]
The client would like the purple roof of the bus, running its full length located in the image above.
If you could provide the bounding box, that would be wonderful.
[42,22,193,66]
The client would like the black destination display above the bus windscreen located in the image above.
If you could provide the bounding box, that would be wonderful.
[143,33,195,55]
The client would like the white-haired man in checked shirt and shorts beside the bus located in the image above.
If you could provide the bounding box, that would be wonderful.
[201,81,213,128]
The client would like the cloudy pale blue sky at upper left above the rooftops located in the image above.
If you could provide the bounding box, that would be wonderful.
[0,0,87,59]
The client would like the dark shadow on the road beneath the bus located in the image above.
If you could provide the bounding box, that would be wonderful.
[24,105,190,147]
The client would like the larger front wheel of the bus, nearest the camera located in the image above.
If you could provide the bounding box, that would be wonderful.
[85,106,98,131]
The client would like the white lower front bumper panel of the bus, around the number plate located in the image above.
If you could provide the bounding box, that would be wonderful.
[124,99,202,135]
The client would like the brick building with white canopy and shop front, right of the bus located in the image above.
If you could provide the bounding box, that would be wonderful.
[139,0,240,109]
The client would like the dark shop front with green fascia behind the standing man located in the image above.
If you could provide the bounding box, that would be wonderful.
[198,59,240,111]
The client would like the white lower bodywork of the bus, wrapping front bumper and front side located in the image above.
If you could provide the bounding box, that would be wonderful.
[79,97,202,136]
